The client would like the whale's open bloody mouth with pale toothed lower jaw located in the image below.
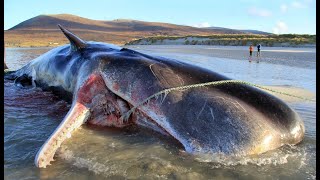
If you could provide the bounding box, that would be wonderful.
[34,74,169,168]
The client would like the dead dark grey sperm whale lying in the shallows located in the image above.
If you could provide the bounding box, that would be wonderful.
[7,26,305,167]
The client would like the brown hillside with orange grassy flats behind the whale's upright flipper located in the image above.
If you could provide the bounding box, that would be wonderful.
[4,14,252,47]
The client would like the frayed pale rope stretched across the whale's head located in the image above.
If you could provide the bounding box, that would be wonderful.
[120,80,315,121]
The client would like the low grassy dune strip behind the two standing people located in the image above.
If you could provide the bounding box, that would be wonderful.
[125,34,316,48]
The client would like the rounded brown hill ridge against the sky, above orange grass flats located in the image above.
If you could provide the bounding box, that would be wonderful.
[9,14,245,35]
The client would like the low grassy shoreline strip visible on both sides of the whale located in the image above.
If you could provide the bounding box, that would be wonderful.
[5,34,316,48]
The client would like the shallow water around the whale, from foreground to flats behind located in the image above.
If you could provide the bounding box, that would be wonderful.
[4,46,316,180]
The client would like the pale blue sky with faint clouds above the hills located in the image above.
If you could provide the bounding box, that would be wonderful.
[4,0,316,34]
